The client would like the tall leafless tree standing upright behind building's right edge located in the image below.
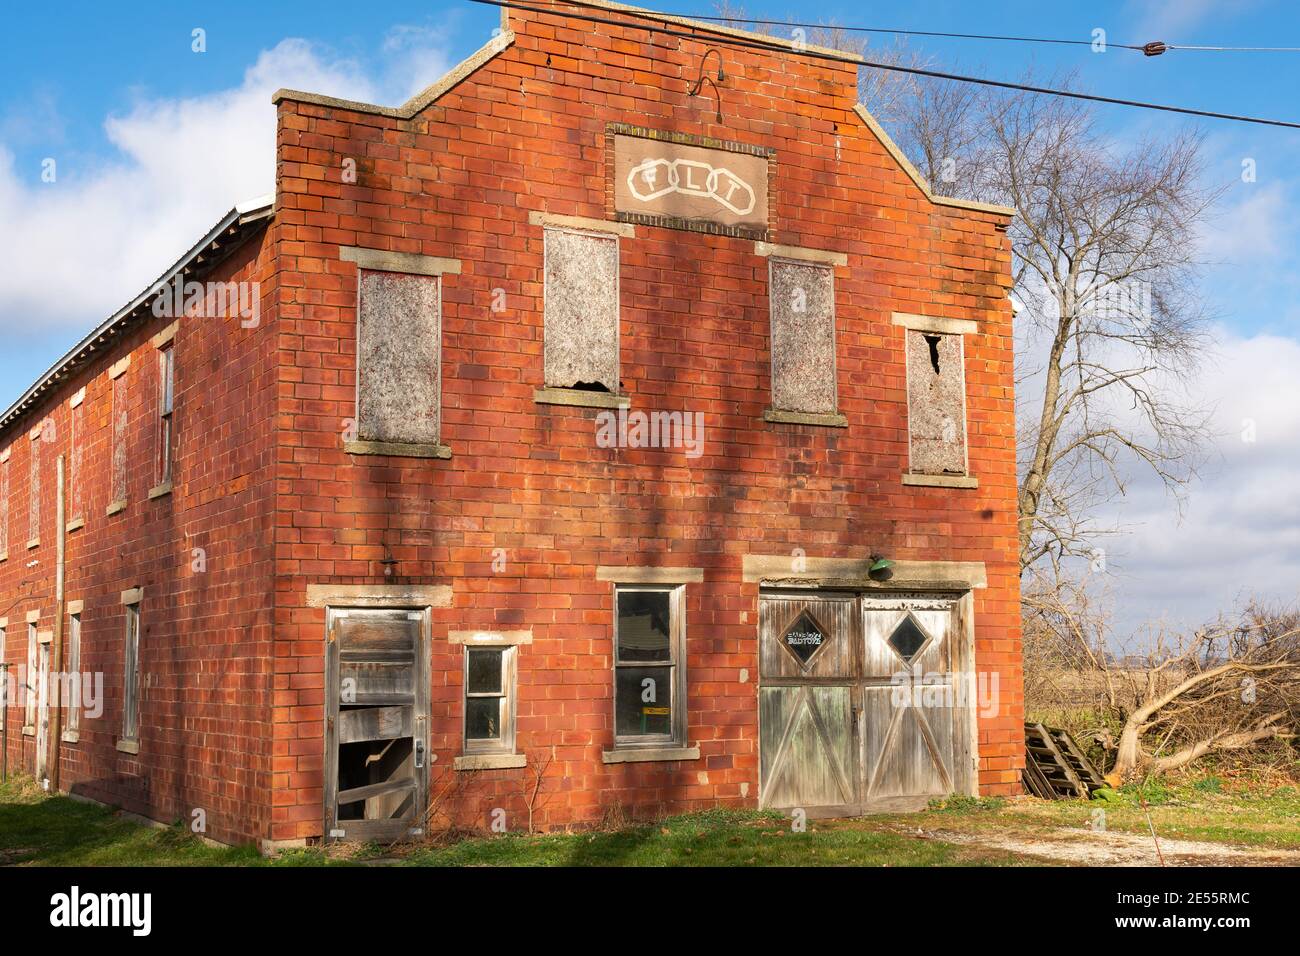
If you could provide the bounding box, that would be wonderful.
[893,81,1219,570]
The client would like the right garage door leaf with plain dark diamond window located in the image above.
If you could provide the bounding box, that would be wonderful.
[861,593,970,810]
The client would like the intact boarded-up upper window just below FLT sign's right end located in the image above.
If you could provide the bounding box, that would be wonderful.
[770,258,837,414]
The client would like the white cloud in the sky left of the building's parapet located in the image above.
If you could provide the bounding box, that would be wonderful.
[0,27,447,343]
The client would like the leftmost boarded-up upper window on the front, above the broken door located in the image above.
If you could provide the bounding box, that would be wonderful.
[356,269,442,445]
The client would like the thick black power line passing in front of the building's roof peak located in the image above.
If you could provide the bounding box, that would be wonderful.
[469,0,1300,130]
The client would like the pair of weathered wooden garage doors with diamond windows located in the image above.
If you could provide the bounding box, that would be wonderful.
[758,591,974,816]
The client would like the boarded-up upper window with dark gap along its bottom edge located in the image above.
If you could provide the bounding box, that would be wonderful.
[543,229,619,393]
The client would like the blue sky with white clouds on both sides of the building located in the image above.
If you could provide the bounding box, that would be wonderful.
[0,0,1300,642]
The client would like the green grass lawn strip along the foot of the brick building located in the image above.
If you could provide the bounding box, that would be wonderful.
[0,777,1300,866]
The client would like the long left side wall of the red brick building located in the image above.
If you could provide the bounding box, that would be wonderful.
[0,228,278,842]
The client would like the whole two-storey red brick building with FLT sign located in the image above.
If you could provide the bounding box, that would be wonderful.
[0,3,1023,842]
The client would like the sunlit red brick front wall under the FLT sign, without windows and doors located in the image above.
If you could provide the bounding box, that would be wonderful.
[273,12,1023,839]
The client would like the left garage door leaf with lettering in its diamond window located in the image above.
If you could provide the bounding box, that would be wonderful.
[758,593,859,816]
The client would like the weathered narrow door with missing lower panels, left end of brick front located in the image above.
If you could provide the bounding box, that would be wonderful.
[325,607,429,840]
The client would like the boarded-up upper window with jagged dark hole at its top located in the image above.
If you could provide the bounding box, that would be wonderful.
[907,329,966,475]
